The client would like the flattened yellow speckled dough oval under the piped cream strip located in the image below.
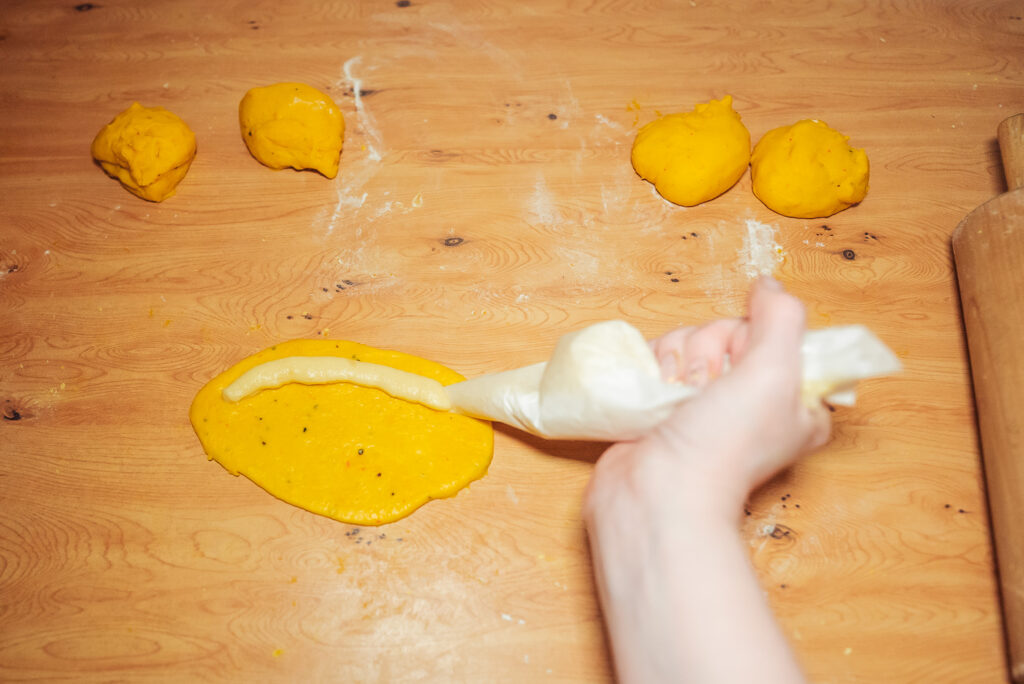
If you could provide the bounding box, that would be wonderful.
[189,340,494,525]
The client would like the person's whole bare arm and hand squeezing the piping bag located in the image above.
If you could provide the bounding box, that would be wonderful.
[584,279,829,684]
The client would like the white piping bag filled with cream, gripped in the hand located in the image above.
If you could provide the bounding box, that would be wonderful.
[444,320,901,441]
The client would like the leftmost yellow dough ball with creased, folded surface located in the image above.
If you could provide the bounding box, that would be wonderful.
[92,102,196,202]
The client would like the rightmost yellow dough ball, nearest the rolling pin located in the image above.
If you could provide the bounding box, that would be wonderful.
[751,119,868,218]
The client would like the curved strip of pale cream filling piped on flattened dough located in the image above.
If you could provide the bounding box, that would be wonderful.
[222,356,452,411]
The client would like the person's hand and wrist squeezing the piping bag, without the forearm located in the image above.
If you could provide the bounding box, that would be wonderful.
[588,277,829,514]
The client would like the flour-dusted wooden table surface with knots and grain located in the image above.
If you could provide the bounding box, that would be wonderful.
[0,0,1024,683]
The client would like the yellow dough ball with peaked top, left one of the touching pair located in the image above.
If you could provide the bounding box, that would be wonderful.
[631,95,751,207]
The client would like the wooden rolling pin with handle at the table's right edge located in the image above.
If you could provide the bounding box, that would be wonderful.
[952,114,1024,684]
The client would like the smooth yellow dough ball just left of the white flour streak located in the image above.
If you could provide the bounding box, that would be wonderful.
[239,83,345,178]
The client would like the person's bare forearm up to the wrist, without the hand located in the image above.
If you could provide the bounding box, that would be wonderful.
[589,497,804,684]
